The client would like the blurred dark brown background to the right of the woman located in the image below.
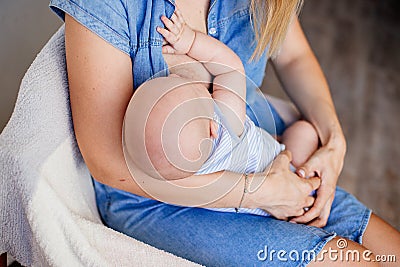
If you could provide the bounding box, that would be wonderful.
[262,0,400,229]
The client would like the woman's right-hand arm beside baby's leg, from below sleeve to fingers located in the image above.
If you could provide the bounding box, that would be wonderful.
[273,19,346,226]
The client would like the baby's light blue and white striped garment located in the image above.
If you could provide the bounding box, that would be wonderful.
[196,104,285,216]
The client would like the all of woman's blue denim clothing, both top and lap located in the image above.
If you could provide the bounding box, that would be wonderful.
[50,0,371,266]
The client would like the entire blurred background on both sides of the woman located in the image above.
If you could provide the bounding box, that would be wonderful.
[0,0,400,229]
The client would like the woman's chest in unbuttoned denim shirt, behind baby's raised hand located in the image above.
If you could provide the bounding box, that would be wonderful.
[129,0,266,89]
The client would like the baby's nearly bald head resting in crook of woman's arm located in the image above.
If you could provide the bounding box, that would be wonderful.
[124,76,217,180]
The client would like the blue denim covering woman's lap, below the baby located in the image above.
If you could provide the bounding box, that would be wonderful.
[94,179,370,266]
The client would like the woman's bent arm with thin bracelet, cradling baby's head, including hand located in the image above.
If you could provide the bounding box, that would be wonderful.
[65,15,319,218]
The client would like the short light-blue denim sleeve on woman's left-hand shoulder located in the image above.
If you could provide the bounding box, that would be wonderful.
[49,0,131,55]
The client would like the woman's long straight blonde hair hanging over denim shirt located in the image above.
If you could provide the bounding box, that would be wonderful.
[250,0,303,59]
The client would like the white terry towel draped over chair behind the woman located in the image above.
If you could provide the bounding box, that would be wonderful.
[0,27,200,266]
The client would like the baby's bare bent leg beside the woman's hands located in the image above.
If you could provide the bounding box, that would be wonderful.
[281,120,318,168]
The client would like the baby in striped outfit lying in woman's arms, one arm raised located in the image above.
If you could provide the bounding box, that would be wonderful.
[123,9,318,216]
